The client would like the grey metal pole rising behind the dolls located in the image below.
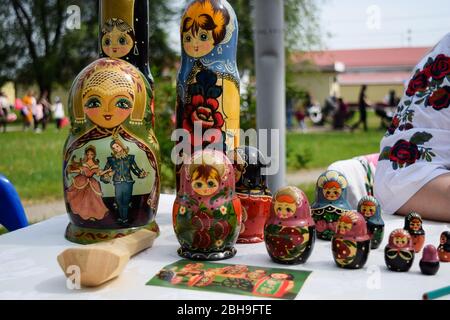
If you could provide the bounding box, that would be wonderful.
[254,0,286,192]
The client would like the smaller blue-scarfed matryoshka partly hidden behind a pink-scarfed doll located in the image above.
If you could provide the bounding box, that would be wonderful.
[358,196,384,249]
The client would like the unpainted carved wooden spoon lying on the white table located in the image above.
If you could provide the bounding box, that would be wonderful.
[58,229,157,287]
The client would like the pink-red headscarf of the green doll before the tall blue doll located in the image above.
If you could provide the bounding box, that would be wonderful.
[178,149,235,209]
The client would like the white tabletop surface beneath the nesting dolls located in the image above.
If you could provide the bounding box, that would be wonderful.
[0,195,450,300]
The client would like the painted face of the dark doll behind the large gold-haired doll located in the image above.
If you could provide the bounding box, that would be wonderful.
[102,28,134,58]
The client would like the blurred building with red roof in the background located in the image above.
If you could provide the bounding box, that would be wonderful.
[291,47,431,104]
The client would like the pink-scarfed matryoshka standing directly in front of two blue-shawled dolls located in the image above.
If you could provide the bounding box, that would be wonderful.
[332,211,370,269]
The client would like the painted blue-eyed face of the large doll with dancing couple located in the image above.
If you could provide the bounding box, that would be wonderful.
[83,87,134,129]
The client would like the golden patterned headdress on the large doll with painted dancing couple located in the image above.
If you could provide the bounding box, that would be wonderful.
[71,58,148,124]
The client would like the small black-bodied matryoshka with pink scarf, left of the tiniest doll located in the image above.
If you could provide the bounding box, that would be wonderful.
[384,229,414,272]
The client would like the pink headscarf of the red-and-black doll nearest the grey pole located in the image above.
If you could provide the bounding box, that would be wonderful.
[267,187,314,227]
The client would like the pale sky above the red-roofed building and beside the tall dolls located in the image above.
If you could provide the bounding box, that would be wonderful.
[171,0,450,49]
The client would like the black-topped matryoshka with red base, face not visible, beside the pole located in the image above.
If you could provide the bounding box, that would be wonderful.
[233,146,272,243]
